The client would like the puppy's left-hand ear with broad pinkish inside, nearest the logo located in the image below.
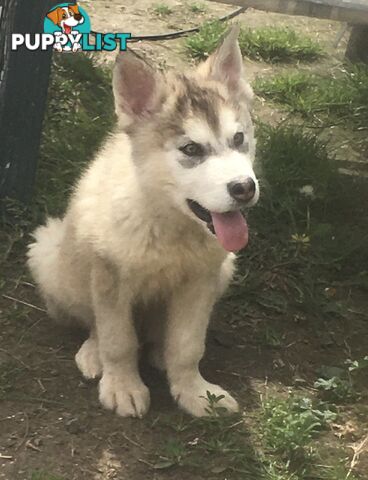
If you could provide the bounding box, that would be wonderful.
[113,50,163,126]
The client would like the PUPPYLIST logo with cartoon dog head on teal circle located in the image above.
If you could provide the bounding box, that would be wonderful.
[12,2,131,52]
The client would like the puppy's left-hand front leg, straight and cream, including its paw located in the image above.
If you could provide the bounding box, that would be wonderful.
[92,260,149,417]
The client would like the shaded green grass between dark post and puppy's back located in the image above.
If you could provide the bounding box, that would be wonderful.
[0,55,114,272]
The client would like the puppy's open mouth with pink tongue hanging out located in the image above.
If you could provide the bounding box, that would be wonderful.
[187,200,248,252]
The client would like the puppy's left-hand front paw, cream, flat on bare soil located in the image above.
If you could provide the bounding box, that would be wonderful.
[99,374,150,418]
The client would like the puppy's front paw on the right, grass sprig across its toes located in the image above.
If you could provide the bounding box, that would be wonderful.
[171,378,239,417]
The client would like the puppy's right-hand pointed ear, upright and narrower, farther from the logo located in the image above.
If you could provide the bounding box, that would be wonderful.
[200,25,253,101]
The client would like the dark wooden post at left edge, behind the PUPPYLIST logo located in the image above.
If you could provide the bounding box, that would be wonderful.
[0,0,57,202]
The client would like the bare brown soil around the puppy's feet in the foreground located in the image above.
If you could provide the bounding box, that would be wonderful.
[0,270,368,480]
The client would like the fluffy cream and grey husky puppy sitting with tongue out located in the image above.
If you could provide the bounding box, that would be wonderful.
[28,27,259,417]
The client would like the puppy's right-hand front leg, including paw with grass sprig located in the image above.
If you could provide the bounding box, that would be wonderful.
[165,278,238,417]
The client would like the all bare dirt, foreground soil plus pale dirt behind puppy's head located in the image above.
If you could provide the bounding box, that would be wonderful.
[0,0,368,480]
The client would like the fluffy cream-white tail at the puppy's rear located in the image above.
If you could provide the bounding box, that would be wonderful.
[27,218,65,319]
